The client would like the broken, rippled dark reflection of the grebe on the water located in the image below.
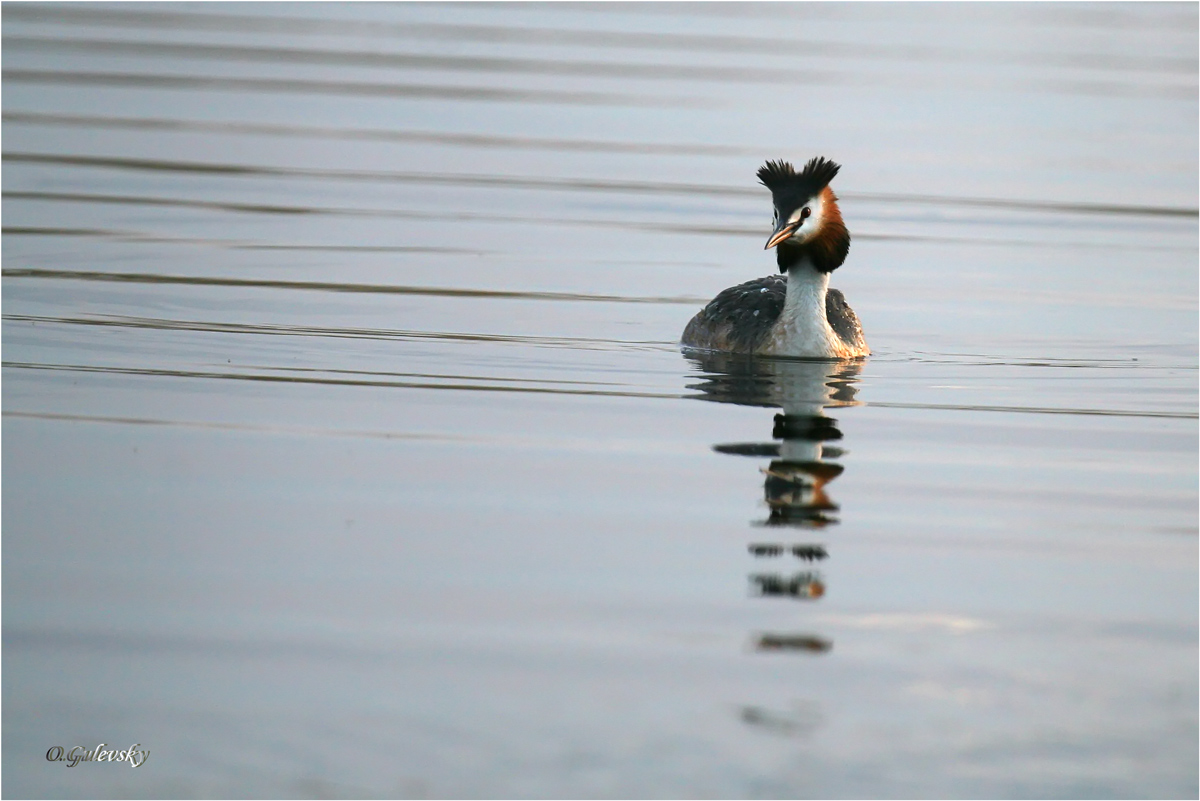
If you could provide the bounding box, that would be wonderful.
[689,354,862,654]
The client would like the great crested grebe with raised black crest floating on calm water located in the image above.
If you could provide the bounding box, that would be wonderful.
[683,157,871,359]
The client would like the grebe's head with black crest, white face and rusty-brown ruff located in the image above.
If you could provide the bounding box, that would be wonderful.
[758,156,850,272]
